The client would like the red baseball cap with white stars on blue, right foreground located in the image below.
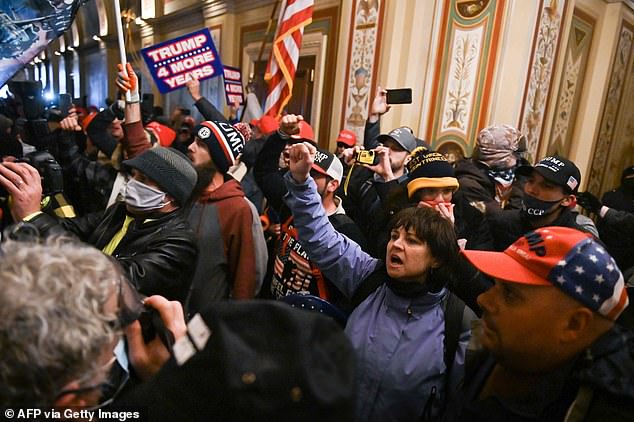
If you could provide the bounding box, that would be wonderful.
[463,227,628,320]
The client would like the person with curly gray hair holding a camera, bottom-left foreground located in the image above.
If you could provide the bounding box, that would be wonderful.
[0,238,185,409]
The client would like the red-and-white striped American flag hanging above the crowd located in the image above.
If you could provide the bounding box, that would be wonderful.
[264,0,314,117]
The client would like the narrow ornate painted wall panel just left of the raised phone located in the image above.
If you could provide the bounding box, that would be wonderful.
[341,0,385,145]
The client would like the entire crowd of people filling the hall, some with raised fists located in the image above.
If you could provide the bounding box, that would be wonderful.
[0,64,634,421]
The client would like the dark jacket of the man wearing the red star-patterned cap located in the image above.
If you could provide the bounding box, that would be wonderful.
[442,325,634,422]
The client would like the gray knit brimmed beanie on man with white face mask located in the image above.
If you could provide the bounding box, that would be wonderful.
[123,147,198,205]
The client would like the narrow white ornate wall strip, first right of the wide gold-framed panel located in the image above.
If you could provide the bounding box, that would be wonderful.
[519,0,568,161]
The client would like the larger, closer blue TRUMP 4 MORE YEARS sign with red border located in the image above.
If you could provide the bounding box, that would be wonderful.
[141,28,223,94]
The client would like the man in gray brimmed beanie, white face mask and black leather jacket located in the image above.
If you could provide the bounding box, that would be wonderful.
[0,148,197,302]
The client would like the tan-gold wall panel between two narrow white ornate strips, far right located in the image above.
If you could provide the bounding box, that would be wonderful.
[546,9,595,157]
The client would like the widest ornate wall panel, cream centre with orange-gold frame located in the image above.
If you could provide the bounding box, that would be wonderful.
[427,0,506,156]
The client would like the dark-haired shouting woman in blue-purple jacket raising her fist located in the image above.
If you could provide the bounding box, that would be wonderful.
[285,143,475,421]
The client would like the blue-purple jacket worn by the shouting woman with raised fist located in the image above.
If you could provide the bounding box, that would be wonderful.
[284,172,470,421]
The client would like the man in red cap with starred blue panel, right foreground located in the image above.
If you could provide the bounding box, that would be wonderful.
[446,227,634,422]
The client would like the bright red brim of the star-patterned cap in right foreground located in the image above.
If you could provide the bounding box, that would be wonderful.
[462,250,552,286]
